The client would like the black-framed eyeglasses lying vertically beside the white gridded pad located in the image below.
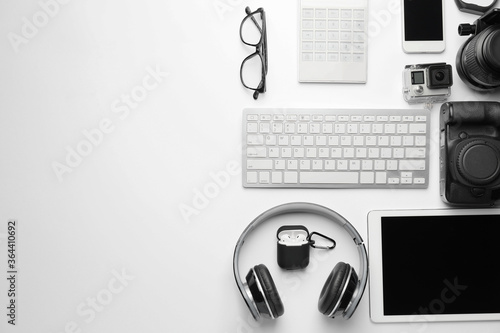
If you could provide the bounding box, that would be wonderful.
[240,7,267,99]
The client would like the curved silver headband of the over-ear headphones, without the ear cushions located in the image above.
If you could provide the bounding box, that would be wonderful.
[233,202,368,319]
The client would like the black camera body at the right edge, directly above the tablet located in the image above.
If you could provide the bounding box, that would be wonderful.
[440,102,500,206]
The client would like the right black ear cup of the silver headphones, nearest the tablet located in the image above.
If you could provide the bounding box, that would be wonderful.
[318,262,358,318]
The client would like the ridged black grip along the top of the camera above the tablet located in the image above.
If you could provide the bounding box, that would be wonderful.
[441,102,500,127]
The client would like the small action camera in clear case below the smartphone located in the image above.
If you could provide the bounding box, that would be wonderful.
[403,63,453,104]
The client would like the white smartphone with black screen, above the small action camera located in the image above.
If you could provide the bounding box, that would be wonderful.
[402,0,445,53]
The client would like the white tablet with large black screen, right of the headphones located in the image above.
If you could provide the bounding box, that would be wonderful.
[368,209,500,322]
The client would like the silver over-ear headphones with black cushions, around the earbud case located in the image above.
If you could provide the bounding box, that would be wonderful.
[233,202,368,320]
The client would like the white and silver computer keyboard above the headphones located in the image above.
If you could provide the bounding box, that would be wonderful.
[243,108,430,188]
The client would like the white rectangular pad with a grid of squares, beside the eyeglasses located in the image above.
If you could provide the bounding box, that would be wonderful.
[298,0,368,83]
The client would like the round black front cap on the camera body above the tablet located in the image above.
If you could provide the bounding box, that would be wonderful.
[457,140,500,186]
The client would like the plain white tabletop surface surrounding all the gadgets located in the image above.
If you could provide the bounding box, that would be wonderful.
[0,0,500,333]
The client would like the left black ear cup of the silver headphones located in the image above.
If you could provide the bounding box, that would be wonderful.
[246,264,285,319]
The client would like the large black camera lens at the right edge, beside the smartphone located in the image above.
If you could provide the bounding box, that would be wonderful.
[457,24,500,91]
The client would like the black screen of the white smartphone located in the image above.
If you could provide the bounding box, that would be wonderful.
[404,0,444,41]
